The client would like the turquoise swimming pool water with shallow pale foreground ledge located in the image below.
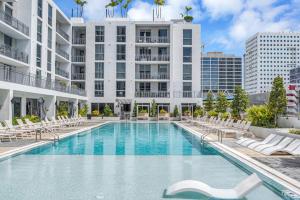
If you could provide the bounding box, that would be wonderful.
[0,123,288,200]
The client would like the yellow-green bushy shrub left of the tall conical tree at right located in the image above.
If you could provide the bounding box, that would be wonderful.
[247,105,275,128]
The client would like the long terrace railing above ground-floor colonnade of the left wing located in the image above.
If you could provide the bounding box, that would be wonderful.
[0,64,86,96]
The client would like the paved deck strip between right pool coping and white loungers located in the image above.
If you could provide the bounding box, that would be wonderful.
[182,122,300,181]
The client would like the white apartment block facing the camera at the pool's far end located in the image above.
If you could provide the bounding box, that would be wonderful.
[72,18,202,114]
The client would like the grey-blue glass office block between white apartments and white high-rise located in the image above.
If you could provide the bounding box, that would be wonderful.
[201,52,242,99]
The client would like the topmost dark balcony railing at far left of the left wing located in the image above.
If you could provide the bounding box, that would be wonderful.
[0,10,29,36]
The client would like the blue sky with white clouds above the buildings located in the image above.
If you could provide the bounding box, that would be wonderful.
[55,0,300,56]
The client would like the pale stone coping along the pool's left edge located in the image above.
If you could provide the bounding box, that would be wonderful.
[0,121,112,162]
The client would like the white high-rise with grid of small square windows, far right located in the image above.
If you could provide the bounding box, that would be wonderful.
[244,32,300,94]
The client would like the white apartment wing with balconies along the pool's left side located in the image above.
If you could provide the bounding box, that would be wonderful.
[0,0,87,121]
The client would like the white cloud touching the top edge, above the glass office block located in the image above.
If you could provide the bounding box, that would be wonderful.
[202,0,244,19]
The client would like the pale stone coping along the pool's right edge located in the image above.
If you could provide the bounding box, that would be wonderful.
[172,122,300,195]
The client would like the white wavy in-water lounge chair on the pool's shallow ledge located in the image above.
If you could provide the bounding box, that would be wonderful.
[166,174,262,199]
